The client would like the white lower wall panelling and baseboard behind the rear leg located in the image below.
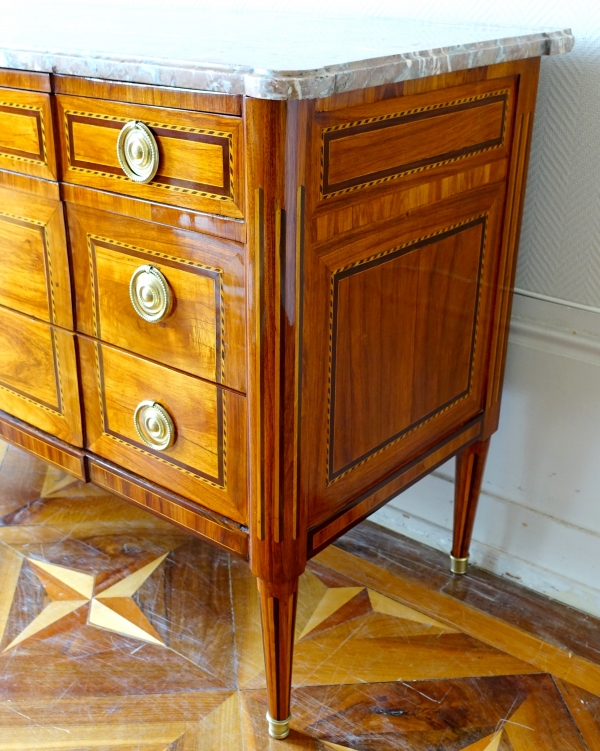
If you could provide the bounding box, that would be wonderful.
[373,295,600,616]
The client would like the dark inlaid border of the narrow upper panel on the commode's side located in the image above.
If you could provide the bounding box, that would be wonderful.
[321,89,510,199]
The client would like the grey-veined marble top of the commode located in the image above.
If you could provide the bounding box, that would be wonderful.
[0,0,574,99]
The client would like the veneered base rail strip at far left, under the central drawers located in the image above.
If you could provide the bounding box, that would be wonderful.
[0,412,87,480]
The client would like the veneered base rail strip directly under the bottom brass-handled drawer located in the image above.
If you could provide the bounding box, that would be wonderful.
[88,455,248,558]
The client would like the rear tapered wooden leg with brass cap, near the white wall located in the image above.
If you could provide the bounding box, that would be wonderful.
[450,438,490,574]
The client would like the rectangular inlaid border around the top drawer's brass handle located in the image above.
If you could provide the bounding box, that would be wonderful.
[64,110,235,203]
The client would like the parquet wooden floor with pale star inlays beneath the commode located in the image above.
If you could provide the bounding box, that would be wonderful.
[0,443,600,751]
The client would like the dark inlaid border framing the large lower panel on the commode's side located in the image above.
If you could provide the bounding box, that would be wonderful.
[325,212,488,486]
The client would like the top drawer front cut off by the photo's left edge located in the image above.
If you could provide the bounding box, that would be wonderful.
[0,88,57,180]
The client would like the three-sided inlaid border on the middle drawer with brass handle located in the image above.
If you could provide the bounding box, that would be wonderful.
[87,233,226,383]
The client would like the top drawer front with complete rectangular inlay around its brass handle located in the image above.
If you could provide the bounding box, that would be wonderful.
[57,94,244,217]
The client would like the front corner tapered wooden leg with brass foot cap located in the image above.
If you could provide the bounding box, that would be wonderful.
[257,579,298,738]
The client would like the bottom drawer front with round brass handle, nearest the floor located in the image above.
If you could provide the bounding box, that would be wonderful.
[79,337,247,523]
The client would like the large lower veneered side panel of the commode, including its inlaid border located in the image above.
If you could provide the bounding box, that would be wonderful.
[302,183,504,526]
